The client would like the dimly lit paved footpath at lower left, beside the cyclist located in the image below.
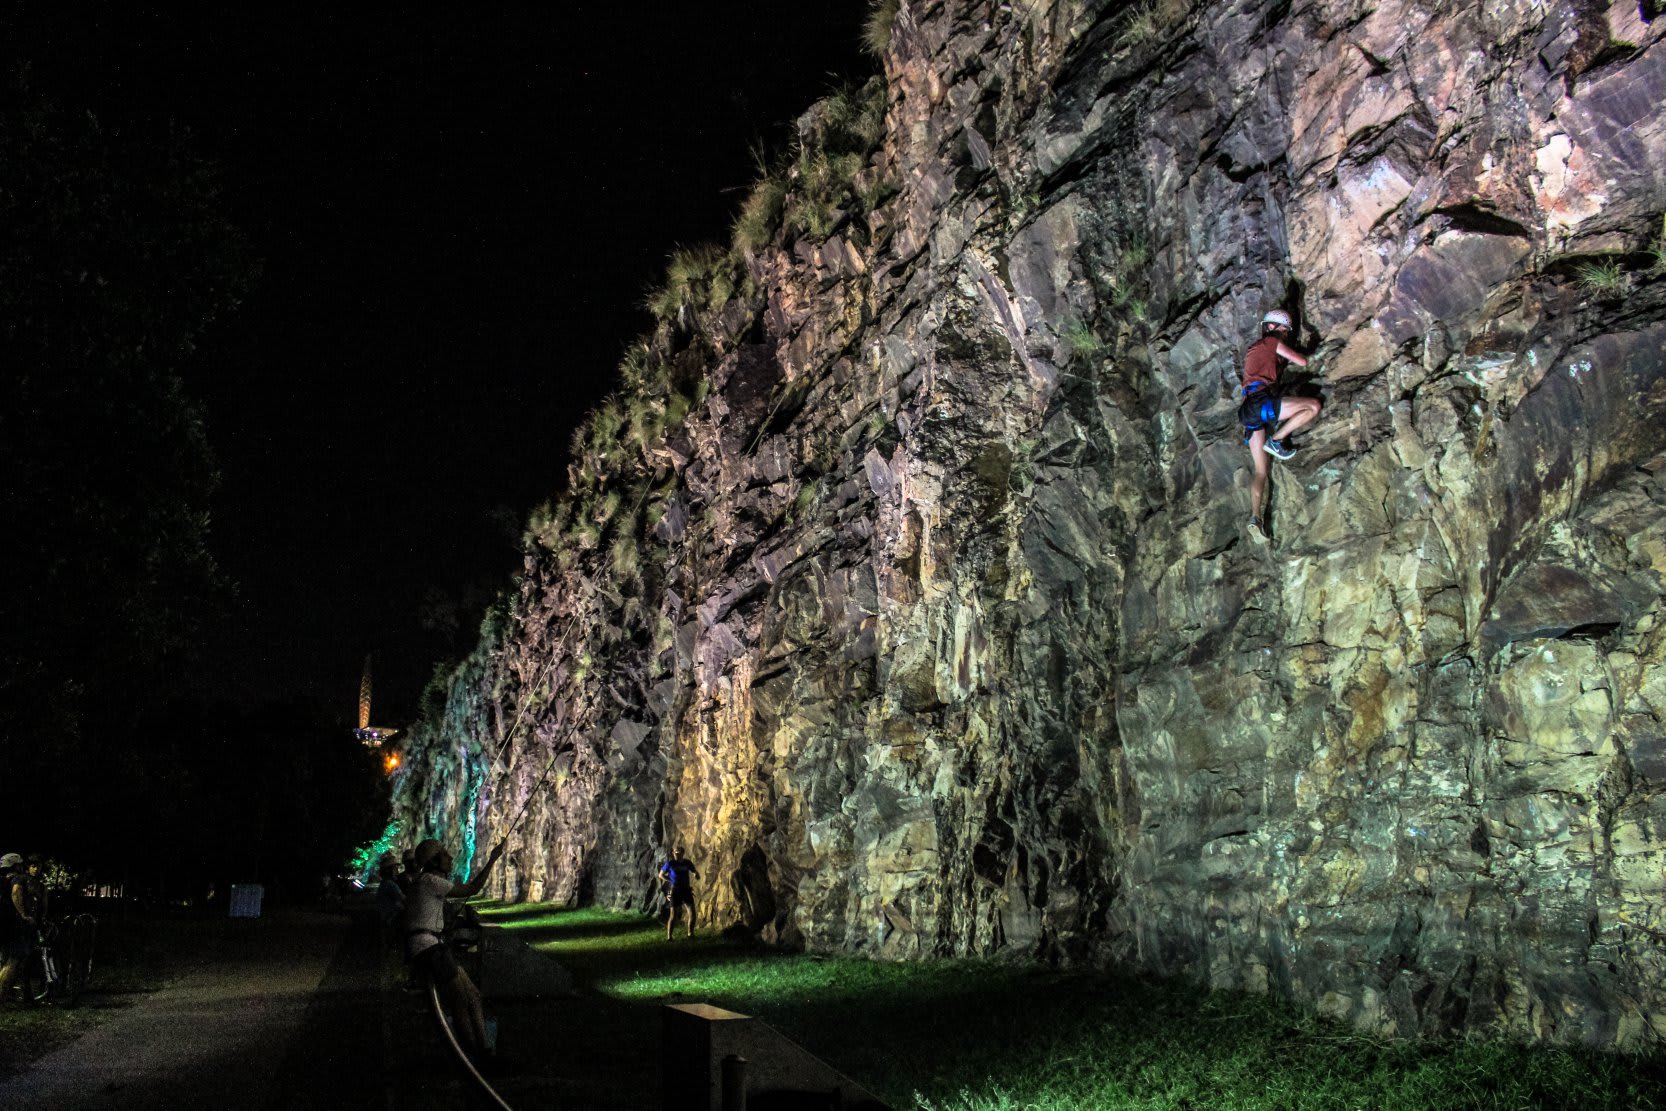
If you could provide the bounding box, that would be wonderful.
[0,911,388,1111]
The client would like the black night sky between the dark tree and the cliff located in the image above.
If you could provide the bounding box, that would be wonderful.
[0,0,875,725]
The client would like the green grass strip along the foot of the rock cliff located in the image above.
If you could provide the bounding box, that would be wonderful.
[486,904,1666,1111]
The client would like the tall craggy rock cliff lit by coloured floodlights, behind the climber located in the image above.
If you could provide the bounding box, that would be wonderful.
[402,0,1666,1046]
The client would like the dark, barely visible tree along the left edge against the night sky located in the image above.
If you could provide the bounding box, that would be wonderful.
[0,73,257,859]
